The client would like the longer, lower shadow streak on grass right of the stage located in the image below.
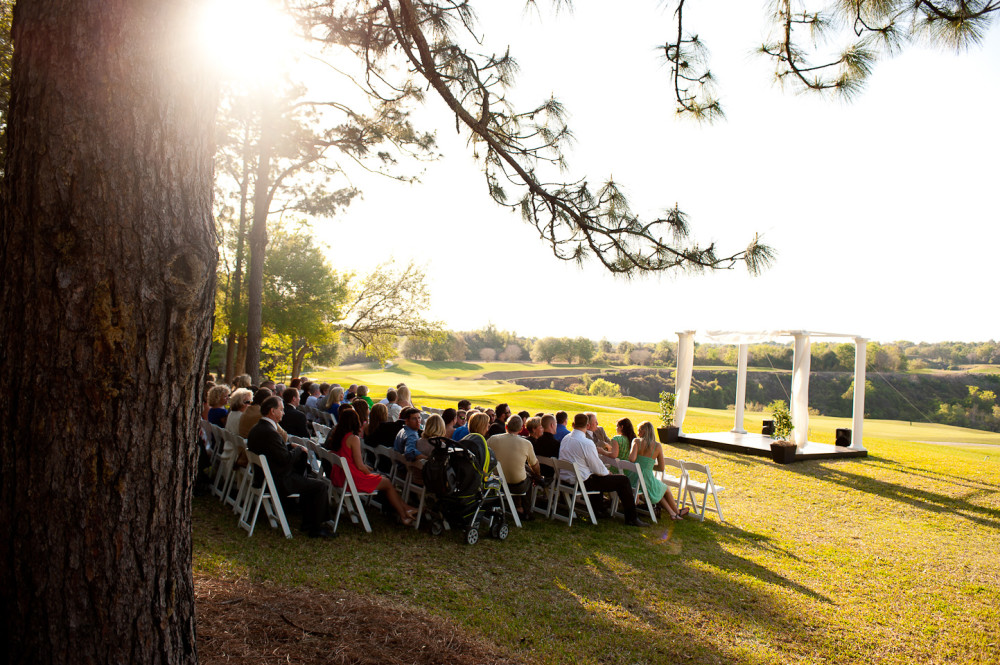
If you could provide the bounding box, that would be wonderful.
[788,461,1000,529]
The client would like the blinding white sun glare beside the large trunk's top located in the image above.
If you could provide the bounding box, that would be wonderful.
[197,0,298,82]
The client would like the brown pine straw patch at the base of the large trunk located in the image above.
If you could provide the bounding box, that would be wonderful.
[194,575,517,665]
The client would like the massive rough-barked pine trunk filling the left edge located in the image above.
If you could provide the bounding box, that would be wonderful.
[0,0,217,664]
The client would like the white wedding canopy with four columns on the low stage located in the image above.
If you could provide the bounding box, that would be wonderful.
[674,330,868,451]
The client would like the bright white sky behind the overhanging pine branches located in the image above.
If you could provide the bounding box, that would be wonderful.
[205,0,1000,341]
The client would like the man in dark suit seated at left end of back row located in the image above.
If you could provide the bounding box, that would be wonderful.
[247,396,334,538]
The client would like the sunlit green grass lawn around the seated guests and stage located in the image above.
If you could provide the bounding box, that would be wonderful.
[194,365,1000,665]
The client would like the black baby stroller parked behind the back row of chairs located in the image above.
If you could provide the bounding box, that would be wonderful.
[423,434,510,545]
